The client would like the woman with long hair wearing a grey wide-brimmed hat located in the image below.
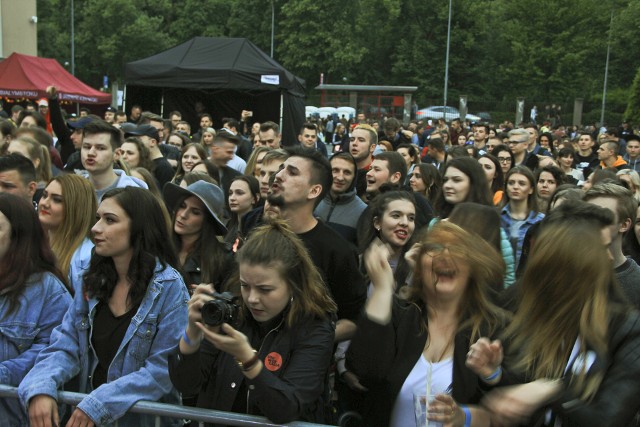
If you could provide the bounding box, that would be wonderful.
[163,181,234,291]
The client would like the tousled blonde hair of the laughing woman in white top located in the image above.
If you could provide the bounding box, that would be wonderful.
[409,221,508,343]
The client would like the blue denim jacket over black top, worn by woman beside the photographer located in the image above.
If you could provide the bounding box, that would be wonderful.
[18,263,189,427]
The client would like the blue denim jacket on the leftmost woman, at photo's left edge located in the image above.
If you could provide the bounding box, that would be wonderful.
[0,272,71,427]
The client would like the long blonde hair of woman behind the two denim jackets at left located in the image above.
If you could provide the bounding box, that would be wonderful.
[50,174,98,277]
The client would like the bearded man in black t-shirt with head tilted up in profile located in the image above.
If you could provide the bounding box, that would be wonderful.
[268,147,367,342]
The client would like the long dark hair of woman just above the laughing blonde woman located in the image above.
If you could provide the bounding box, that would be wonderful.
[435,156,493,218]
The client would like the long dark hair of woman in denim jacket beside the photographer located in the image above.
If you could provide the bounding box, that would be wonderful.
[84,187,177,306]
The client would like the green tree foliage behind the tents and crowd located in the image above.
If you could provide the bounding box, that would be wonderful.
[33,0,640,118]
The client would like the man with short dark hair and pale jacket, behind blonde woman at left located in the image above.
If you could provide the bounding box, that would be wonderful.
[80,120,147,201]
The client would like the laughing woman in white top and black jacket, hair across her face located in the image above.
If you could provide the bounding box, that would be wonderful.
[347,221,506,426]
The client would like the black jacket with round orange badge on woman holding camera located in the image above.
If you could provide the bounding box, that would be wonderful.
[169,317,335,424]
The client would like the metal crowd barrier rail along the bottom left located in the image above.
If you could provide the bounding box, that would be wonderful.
[0,385,336,427]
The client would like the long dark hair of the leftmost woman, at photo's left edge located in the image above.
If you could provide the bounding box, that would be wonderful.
[0,193,67,313]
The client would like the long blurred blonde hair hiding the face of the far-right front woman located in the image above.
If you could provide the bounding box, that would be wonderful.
[505,222,616,399]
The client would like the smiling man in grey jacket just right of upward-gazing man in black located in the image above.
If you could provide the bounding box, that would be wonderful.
[314,152,367,245]
